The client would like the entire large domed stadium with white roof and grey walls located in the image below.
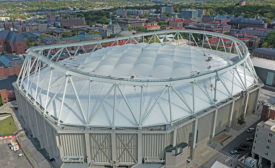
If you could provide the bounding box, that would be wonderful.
[14,30,260,167]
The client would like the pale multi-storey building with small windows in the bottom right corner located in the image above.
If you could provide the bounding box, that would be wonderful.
[252,119,275,168]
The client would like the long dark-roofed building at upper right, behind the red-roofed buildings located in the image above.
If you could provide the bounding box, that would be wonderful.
[229,16,267,29]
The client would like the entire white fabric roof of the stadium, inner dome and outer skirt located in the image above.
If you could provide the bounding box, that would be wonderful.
[23,43,255,127]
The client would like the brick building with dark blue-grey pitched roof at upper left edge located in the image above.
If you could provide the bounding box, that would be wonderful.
[0,30,27,54]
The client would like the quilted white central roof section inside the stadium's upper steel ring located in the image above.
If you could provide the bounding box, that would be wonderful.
[61,43,236,79]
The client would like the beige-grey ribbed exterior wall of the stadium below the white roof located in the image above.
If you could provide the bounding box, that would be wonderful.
[14,84,260,167]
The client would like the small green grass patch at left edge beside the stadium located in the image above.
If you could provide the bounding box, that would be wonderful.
[0,116,16,135]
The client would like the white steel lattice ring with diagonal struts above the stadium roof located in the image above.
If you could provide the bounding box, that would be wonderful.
[16,30,258,129]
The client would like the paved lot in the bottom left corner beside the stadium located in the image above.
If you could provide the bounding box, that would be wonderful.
[0,143,31,168]
